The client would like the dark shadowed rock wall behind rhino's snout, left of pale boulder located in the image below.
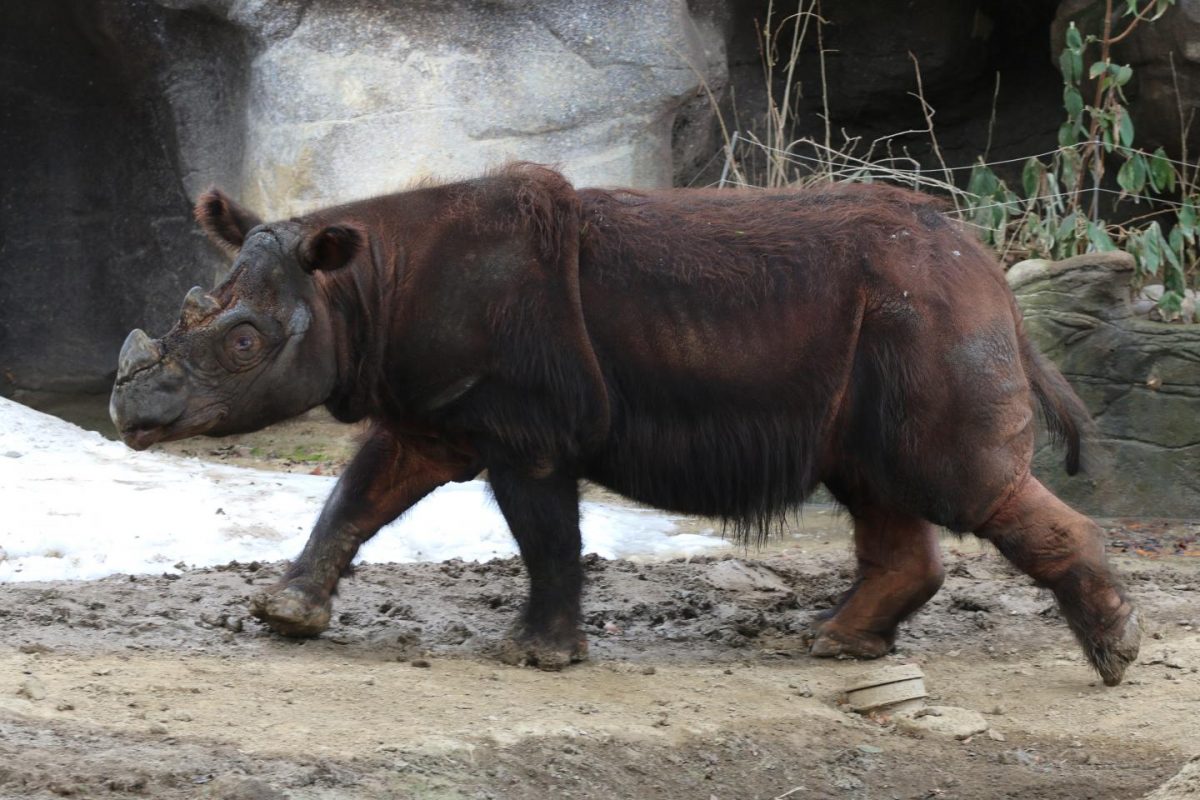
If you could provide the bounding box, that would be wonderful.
[0,0,241,395]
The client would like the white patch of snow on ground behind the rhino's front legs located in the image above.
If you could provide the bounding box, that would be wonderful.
[0,398,724,582]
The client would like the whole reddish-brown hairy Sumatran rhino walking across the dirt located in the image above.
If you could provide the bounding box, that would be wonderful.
[112,164,1139,685]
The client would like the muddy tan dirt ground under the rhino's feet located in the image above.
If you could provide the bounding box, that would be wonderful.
[0,407,1200,800]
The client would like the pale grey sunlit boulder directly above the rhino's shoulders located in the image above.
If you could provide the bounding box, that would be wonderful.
[172,0,725,216]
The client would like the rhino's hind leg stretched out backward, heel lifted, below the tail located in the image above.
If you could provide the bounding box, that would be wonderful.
[976,476,1141,686]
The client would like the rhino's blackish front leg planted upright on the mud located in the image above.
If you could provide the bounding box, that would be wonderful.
[488,468,588,669]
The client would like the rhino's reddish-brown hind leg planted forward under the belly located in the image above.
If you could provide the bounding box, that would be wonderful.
[811,509,946,658]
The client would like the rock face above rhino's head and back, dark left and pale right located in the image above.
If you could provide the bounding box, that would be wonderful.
[0,0,725,395]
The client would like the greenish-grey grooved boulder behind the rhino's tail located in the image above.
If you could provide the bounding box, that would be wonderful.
[1008,252,1200,517]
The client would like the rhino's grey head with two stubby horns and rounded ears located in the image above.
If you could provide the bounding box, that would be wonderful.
[109,190,366,450]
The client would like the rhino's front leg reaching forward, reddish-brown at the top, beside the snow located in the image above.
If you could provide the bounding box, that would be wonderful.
[250,427,478,637]
